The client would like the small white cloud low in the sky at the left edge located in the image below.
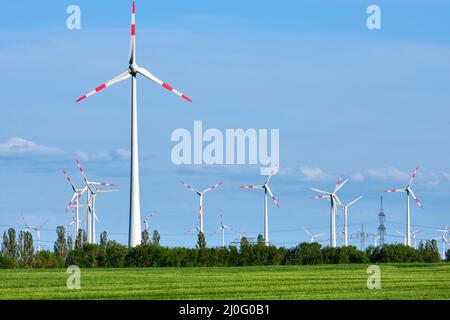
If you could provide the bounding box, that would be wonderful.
[0,137,64,156]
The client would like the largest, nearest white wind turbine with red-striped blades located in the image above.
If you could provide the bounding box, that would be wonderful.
[76,1,192,247]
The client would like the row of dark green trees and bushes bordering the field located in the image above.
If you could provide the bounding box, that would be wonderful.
[0,226,444,268]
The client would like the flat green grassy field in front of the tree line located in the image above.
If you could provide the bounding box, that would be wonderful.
[0,264,450,299]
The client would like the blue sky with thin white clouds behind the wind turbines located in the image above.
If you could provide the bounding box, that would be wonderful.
[0,0,450,250]
